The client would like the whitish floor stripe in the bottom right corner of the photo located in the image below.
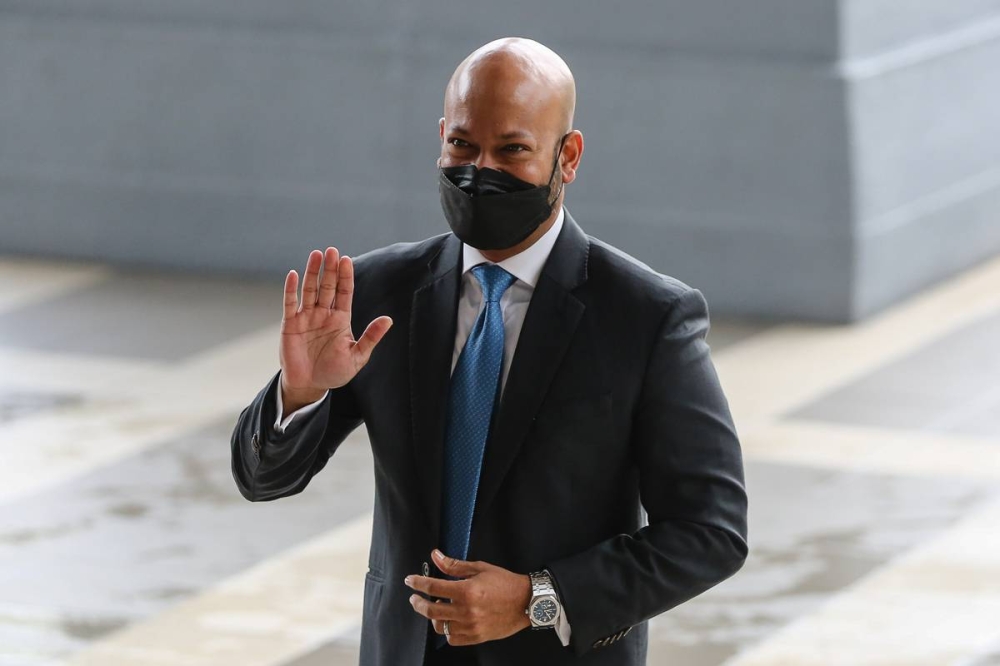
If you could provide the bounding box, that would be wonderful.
[726,501,1000,666]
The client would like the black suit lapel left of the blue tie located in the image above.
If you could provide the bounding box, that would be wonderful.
[410,236,462,543]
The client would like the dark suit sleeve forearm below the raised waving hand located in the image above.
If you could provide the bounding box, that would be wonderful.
[230,373,362,502]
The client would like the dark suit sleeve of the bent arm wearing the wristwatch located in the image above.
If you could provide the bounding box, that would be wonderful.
[546,289,748,654]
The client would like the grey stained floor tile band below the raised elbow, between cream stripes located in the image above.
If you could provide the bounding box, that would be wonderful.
[0,414,373,663]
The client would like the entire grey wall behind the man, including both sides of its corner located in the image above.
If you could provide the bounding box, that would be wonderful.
[0,0,1000,321]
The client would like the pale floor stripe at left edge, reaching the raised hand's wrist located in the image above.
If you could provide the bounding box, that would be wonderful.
[0,328,278,501]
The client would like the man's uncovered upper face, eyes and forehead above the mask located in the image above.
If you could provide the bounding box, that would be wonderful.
[438,69,562,190]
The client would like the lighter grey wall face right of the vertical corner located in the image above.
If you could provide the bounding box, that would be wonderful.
[839,0,1000,314]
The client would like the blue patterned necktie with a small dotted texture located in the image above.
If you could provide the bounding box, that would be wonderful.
[441,264,517,560]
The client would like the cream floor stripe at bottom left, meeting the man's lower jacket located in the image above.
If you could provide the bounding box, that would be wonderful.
[66,516,374,666]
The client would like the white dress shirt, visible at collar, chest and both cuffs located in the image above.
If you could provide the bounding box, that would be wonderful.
[274,210,570,645]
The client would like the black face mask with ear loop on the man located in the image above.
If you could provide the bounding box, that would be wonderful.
[438,134,569,250]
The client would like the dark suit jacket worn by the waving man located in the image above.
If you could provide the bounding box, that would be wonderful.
[232,213,747,666]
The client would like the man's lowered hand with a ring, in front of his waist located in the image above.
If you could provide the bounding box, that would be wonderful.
[405,550,531,645]
